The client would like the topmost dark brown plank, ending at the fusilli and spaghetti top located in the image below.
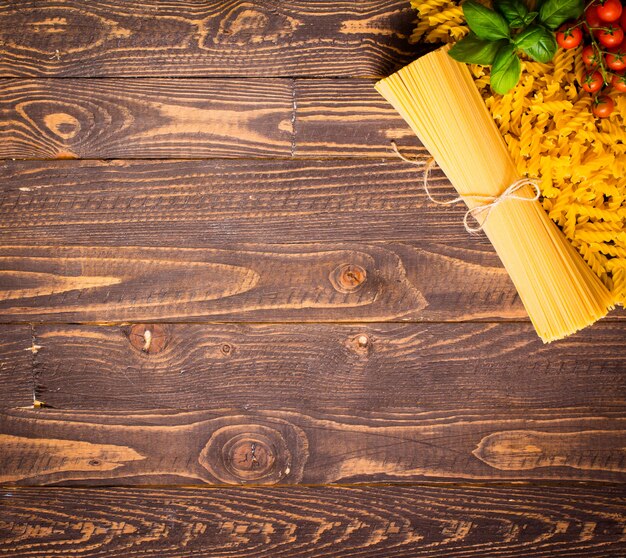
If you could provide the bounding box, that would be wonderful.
[0,0,418,77]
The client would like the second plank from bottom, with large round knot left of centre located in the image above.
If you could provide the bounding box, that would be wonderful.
[0,406,626,485]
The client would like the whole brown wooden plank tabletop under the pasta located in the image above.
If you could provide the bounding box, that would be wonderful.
[0,0,626,558]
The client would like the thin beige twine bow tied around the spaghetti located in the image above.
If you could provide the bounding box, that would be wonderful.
[391,141,541,234]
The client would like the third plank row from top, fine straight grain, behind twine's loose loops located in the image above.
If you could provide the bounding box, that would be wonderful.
[0,155,456,245]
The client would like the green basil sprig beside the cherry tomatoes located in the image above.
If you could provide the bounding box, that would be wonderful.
[449,0,584,94]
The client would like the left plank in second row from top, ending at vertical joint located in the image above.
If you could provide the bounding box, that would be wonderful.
[0,79,294,159]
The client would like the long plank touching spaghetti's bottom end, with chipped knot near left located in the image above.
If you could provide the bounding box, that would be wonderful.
[34,323,626,412]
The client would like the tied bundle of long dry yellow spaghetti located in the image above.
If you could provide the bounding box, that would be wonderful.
[376,47,613,342]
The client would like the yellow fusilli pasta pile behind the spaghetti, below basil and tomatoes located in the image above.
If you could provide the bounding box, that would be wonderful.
[411,0,626,305]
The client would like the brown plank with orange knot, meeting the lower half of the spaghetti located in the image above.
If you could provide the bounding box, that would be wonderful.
[0,242,526,322]
